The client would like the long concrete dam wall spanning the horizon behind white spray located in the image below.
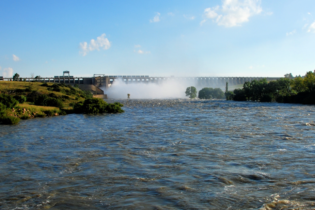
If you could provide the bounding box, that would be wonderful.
[0,74,282,88]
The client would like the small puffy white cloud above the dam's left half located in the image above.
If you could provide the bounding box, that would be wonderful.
[80,34,110,56]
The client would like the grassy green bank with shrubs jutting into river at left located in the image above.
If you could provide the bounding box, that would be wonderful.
[0,81,124,124]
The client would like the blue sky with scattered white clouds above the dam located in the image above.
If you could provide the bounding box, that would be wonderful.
[0,0,315,77]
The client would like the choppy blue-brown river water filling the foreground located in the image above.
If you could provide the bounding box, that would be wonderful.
[0,99,315,210]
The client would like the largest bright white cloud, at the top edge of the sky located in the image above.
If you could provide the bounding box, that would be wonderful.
[204,0,262,27]
